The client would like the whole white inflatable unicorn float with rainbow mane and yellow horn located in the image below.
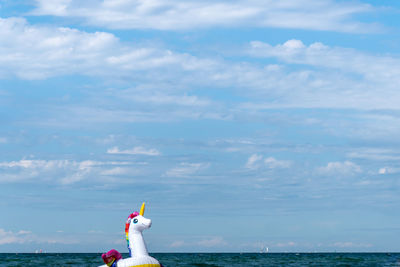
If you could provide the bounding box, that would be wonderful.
[100,202,163,267]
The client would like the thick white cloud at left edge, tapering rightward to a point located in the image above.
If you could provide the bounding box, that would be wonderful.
[0,18,216,79]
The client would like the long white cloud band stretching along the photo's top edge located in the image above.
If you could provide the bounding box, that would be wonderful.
[33,0,378,32]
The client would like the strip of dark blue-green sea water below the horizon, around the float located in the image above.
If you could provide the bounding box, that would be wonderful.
[0,253,400,267]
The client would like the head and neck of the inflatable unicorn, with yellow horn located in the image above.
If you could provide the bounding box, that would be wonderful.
[125,202,151,257]
